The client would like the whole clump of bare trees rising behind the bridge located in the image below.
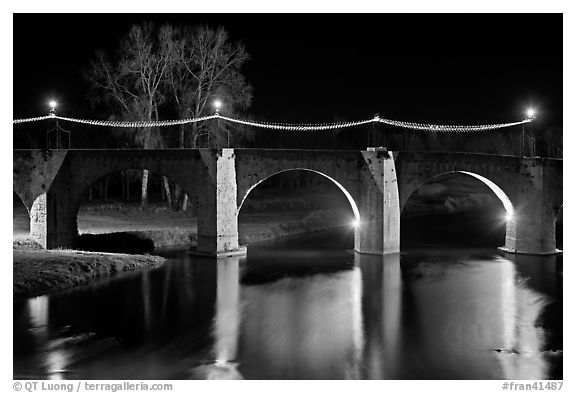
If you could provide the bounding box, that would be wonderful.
[87,23,252,210]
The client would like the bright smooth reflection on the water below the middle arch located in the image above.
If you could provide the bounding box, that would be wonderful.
[240,262,363,379]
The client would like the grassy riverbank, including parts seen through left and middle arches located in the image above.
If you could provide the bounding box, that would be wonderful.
[13,194,345,299]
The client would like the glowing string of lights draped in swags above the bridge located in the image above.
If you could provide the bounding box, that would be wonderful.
[13,113,534,132]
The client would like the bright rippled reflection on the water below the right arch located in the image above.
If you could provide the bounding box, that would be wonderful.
[404,253,549,379]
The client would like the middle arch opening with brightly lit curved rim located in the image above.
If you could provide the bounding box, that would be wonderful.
[237,168,361,249]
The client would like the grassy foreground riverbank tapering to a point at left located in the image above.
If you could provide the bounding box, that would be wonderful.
[13,247,165,299]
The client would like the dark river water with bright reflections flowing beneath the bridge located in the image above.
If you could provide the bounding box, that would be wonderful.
[14,230,562,379]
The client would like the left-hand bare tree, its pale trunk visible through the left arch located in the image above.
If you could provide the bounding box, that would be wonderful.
[86,23,170,207]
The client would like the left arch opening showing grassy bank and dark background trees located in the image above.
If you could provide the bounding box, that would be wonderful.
[74,168,197,253]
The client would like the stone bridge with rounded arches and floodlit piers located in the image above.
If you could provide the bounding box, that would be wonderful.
[13,148,562,256]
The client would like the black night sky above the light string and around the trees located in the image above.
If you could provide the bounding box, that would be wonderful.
[14,14,562,124]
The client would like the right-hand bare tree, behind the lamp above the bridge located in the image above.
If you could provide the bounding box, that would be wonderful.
[165,26,252,147]
